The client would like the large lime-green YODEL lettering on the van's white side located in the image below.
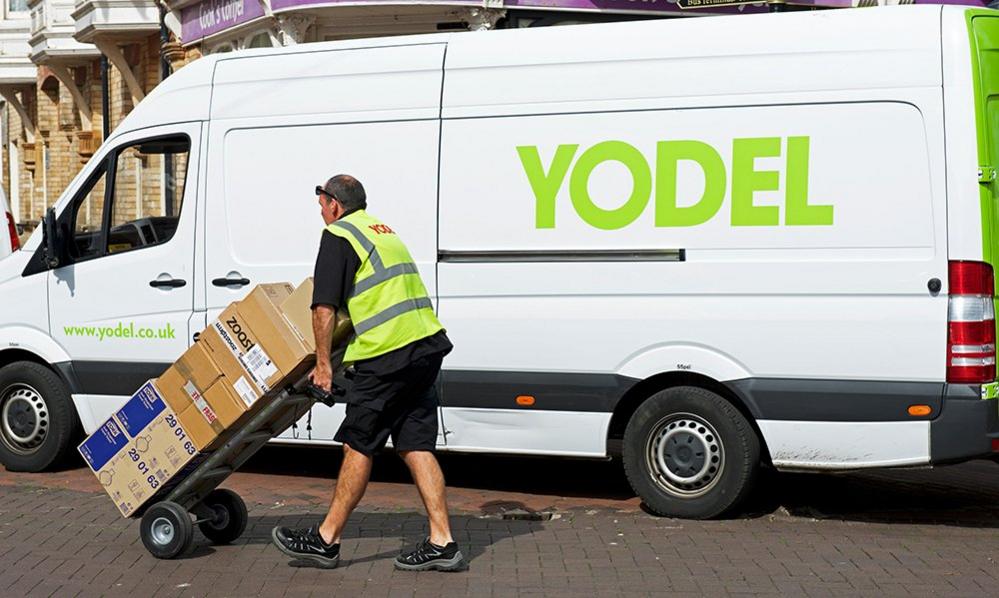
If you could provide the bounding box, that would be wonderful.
[517,137,833,230]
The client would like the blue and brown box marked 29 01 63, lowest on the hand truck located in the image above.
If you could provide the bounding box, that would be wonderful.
[79,381,198,516]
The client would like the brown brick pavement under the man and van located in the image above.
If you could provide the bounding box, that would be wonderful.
[0,450,999,598]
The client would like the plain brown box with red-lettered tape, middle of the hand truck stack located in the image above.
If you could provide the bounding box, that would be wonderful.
[156,342,255,451]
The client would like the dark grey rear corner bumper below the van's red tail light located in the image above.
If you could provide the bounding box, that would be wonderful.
[930,384,999,464]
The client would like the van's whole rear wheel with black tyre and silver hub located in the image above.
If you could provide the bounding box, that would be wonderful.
[623,386,760,519]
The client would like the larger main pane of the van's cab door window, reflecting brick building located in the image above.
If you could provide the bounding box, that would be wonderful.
[107,137,191,254]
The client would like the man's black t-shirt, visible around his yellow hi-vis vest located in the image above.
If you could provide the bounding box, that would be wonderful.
[312,230,453,376]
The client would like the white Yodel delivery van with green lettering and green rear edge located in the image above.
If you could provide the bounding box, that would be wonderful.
[0,6,999,517]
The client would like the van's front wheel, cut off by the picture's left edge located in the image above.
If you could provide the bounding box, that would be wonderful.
[0,361,78,472]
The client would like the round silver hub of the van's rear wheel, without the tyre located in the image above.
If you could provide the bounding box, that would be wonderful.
[646,413,724,498]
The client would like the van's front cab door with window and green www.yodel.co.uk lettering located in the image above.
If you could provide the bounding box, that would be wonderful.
[48,123,201,421]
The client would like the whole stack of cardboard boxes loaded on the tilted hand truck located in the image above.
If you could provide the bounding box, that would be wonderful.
[79,279,336,516]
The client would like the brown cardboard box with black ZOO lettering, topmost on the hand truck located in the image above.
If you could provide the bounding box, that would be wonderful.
[199,283,315,403]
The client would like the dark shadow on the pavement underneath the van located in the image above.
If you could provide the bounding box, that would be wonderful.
[225,447,999,527]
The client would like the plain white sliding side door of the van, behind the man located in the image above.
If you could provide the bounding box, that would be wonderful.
[205,44,444,441]
